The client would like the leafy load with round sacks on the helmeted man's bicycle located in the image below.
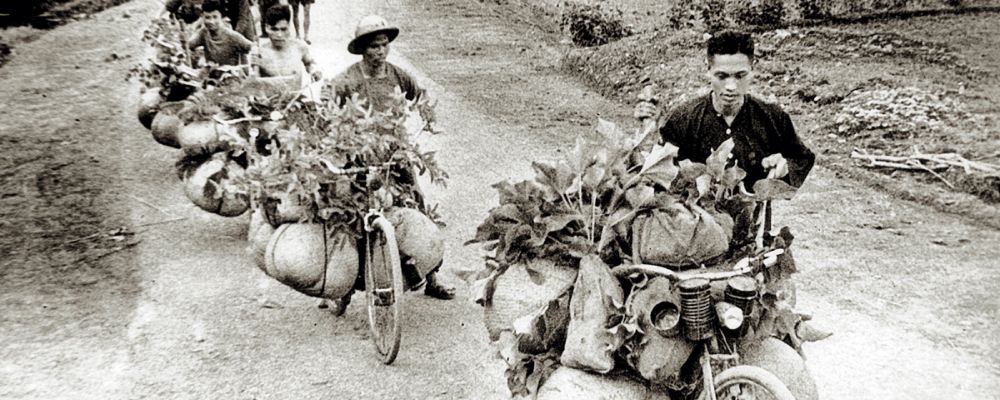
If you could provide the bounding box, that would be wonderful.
[212,83,447,299]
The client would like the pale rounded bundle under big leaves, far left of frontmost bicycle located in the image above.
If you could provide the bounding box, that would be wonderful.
[483,260,576,340]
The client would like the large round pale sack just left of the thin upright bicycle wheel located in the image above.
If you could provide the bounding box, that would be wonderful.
[264,223,359,299]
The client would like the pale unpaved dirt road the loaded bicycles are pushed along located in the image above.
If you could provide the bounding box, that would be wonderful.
[0,0,1000,399]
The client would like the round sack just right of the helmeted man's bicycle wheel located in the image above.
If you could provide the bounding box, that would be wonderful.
[385,207,444,277]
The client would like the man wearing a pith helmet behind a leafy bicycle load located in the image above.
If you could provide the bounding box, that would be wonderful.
[334,15,424,111]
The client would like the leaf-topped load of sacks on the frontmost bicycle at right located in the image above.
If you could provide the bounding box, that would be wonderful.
[467,120,820,398]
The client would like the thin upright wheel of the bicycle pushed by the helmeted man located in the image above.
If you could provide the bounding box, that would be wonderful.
[365,217,403,364]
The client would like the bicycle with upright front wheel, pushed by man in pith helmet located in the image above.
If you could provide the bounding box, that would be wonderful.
[327,163,405,365]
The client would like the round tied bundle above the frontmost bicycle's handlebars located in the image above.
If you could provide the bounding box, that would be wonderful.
[632,203,733,267]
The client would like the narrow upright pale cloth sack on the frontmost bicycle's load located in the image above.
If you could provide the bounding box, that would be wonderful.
[560,255,625,374]
